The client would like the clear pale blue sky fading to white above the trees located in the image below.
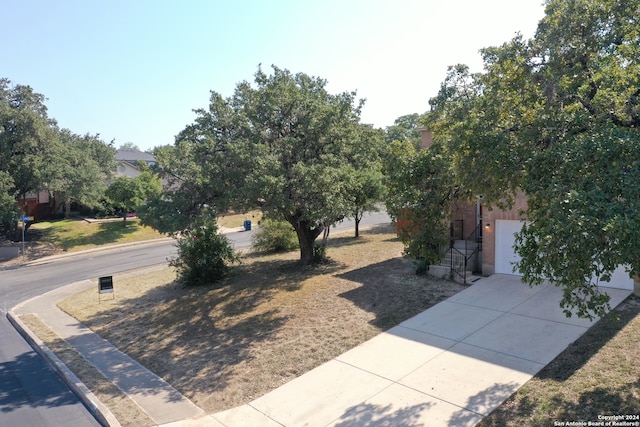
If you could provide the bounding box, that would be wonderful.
[0,0,544,150]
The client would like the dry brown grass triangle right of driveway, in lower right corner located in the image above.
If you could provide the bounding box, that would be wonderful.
[479,296,640,427]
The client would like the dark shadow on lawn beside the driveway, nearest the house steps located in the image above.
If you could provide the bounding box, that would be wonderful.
[337,257,464,330]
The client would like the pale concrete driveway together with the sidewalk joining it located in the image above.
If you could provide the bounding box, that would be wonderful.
[14,275,630,427]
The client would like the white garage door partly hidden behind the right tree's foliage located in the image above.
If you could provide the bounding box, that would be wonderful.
[495,219,633,291]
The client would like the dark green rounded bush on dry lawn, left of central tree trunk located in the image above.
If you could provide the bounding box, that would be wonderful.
[170,214,239,286]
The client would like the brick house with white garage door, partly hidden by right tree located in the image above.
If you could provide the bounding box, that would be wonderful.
[419,128,640,294]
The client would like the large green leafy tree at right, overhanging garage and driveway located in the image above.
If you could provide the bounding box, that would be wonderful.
[428,0,640,317]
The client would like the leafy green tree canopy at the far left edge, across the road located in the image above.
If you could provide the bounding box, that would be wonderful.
[0,79,115,228]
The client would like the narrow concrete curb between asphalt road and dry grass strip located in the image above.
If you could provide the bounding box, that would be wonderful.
[7,310,122,427]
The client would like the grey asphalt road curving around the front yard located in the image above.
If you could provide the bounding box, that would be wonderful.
[0,213,389,427]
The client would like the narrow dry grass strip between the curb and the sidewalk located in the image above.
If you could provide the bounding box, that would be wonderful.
[20,314,154,427]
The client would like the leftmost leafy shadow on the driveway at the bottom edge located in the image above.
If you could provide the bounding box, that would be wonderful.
[334,403,433,427]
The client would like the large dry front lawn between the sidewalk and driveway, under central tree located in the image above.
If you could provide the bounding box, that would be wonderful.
[60,226,463,412]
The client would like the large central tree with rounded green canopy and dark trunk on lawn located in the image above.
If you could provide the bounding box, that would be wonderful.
[145,66,378,263]
